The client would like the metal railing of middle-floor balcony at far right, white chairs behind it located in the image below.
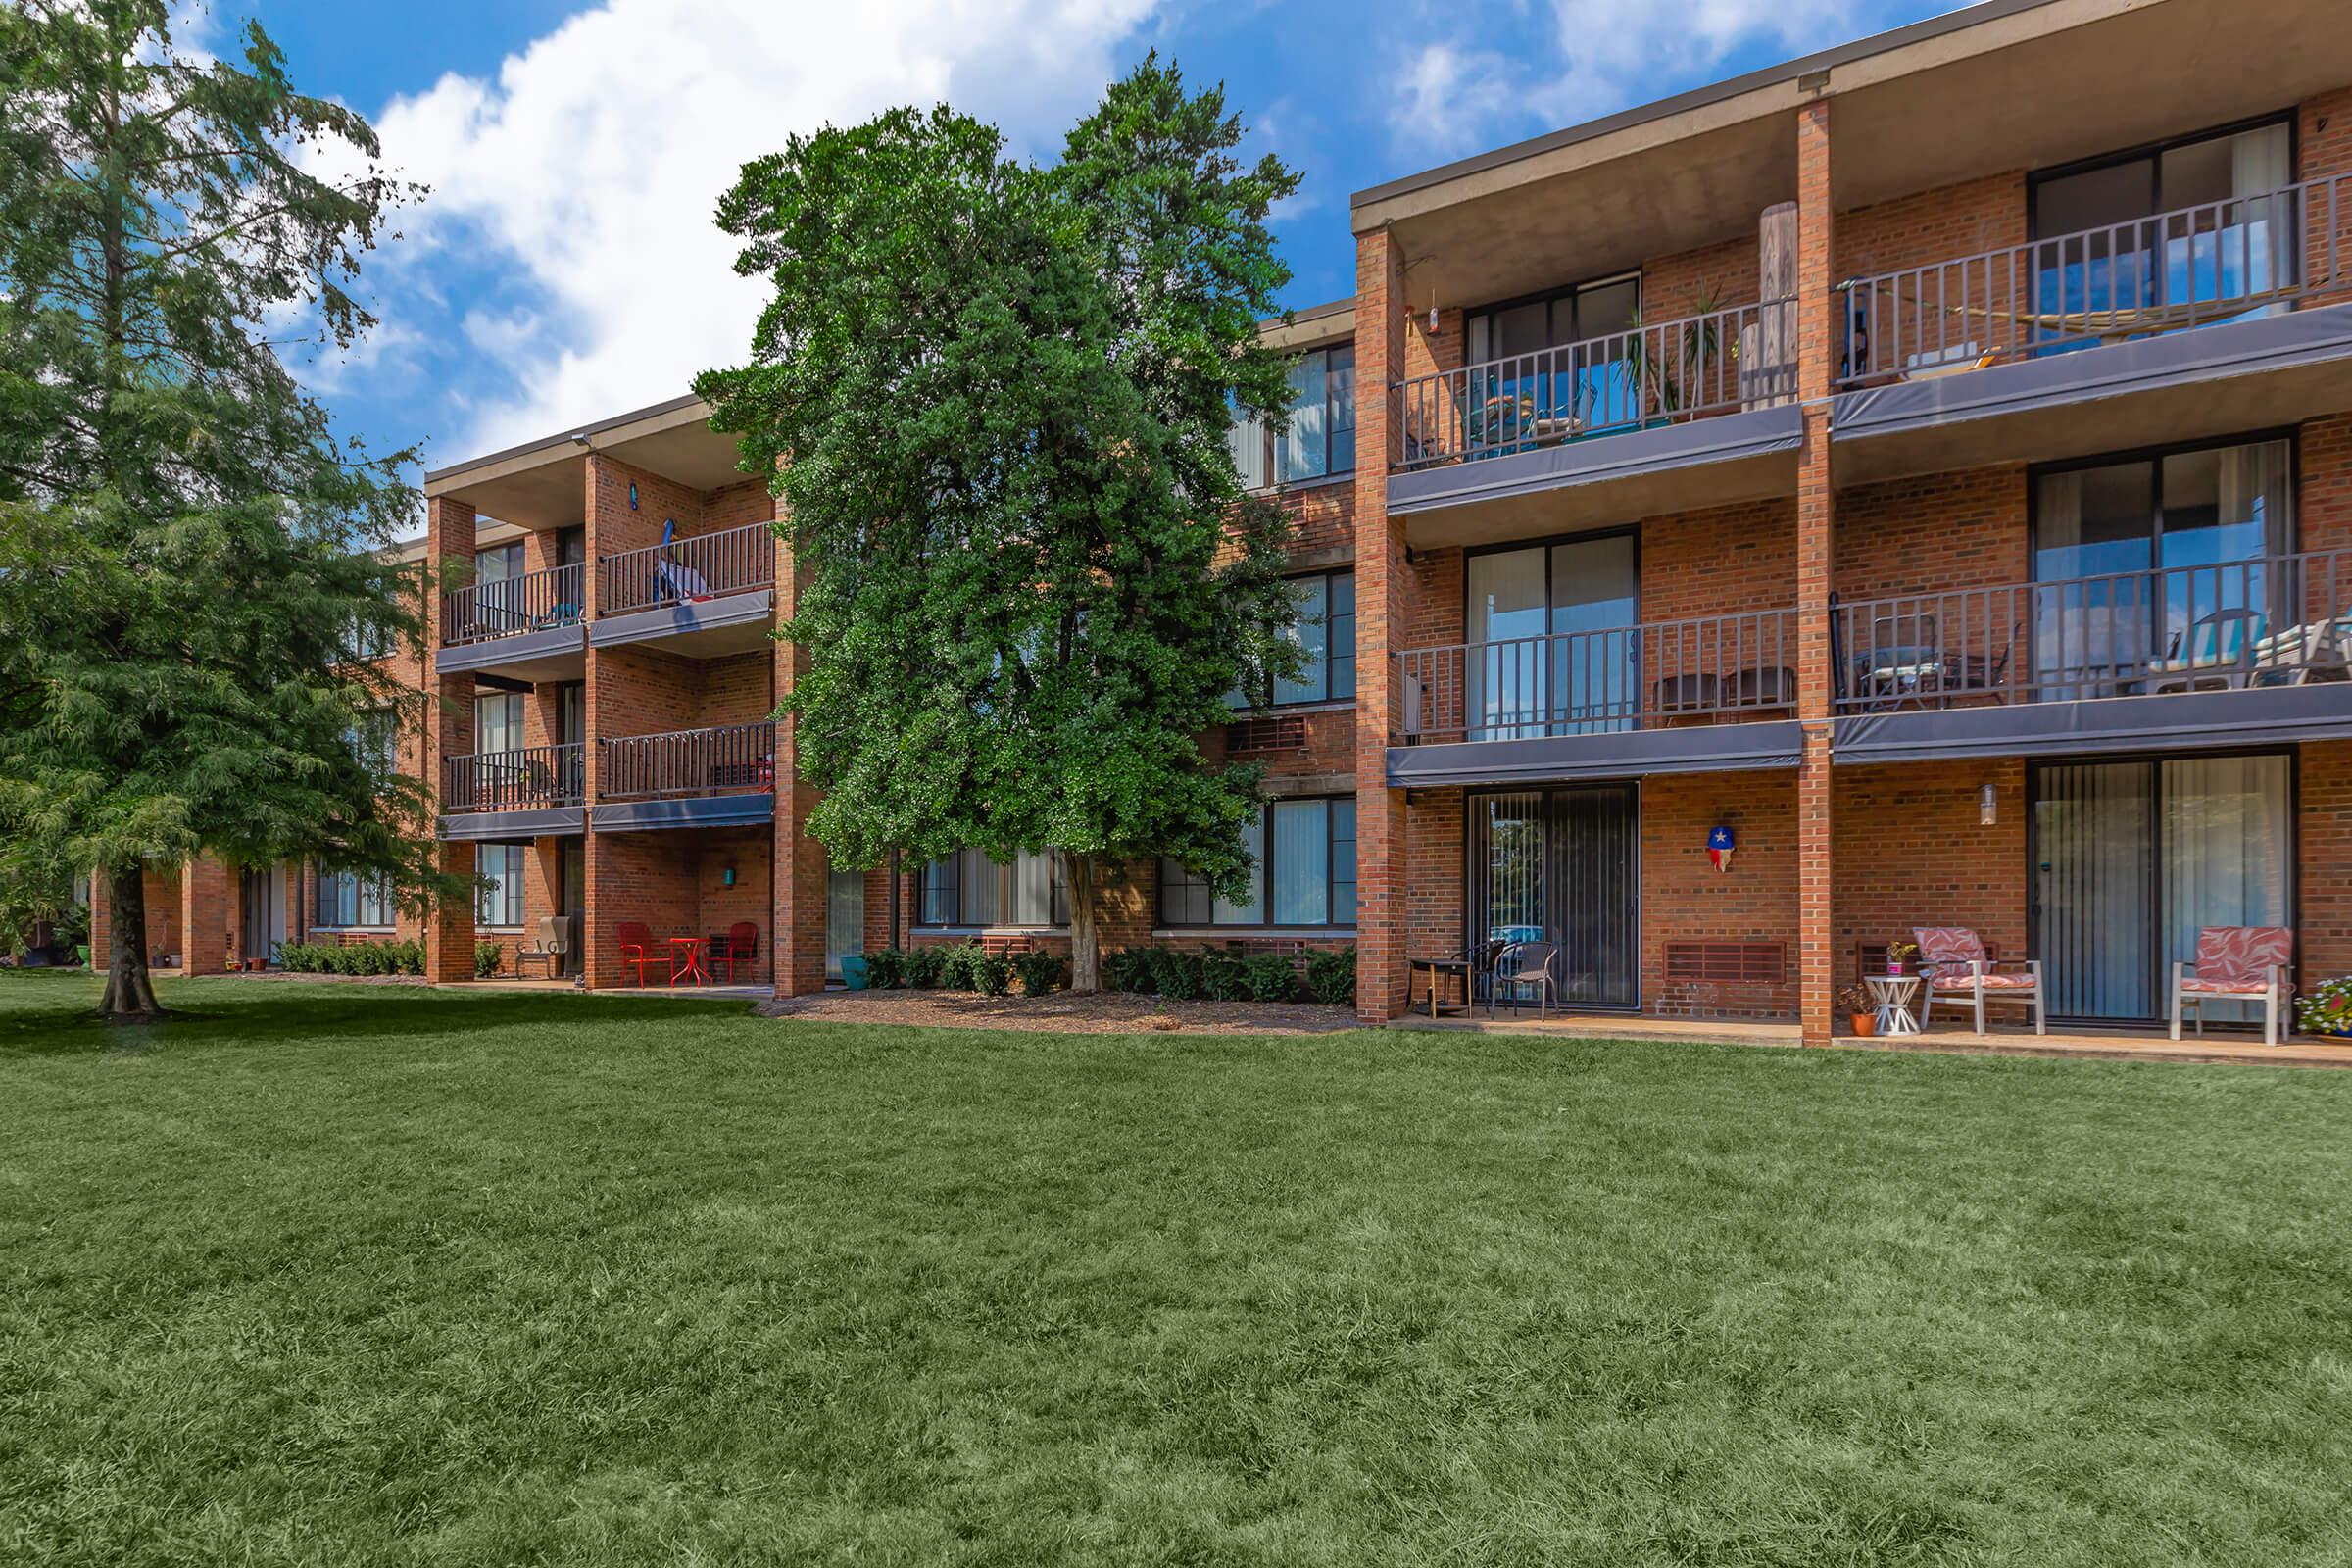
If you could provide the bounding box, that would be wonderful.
[1833,550,2352,712]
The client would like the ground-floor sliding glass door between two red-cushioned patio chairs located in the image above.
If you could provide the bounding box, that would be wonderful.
[2030,753,2295,1022]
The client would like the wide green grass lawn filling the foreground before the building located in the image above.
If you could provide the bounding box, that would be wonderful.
[0,976,2352,1566]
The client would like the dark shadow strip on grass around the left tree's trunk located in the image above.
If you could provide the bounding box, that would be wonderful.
[0,976,753,1057]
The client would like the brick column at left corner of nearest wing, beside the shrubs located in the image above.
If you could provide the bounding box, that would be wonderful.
[1354,230,1409,1022]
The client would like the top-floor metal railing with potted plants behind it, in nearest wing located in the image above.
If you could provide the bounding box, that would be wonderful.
[1390,299,1797,472]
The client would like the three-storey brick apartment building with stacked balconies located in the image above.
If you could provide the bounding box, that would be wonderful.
[91,0,2352,1039]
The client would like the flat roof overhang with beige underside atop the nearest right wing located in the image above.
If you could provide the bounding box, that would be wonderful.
[1352,0,2352,311]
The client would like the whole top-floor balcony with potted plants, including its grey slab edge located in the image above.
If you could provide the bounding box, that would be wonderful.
[1388,299,1804,546]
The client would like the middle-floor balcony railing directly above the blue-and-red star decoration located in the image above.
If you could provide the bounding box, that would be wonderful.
[1395,609,1797,743]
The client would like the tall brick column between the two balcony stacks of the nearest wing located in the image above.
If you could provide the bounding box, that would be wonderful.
[1797,99,1837,1046]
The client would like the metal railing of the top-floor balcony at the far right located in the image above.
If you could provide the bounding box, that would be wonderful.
[1837,174,2352,388]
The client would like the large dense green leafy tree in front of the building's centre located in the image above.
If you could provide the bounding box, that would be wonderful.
[696,59,1298,990]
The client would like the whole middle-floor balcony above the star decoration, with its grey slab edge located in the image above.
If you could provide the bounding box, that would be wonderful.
[1388,609,1799,785]
